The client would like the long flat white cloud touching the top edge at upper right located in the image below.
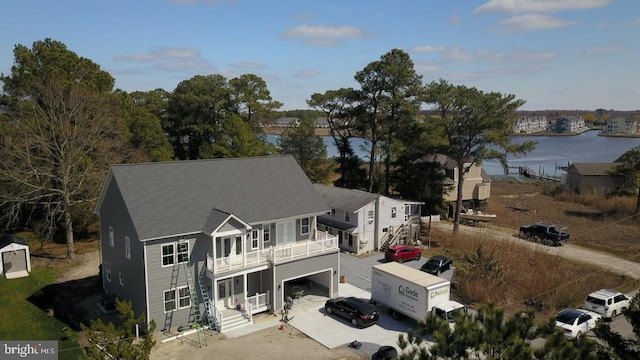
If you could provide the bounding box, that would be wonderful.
[474,0,613,14]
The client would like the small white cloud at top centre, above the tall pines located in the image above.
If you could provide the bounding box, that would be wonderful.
[283,25,368,46]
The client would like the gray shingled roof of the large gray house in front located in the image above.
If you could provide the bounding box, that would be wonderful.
[101,155,330,240]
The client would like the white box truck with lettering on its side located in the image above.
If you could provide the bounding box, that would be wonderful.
[371,262,466,322]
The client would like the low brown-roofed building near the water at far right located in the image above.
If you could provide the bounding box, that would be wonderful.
[565,163,624,193]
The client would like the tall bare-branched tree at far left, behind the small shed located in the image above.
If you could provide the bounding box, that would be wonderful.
[0,39,128,259]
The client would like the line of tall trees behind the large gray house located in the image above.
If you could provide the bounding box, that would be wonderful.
[0,39,640,259]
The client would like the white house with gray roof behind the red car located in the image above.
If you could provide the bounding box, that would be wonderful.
[315,184,422,254]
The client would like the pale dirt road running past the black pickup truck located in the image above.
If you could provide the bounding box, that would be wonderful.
[432,221,640,279]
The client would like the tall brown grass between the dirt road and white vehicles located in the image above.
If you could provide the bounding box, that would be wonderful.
[424,230,632,312]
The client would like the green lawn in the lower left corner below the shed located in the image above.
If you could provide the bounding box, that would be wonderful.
[0,268,84,359]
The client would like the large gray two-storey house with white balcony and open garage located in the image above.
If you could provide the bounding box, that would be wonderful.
[95,156,339,332]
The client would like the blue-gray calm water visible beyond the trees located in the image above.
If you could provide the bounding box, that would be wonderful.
[268,131,640,176]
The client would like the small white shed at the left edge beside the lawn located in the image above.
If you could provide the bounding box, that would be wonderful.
[0,235,31,279]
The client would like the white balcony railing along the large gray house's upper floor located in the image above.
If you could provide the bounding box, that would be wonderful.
[207,231,338,274]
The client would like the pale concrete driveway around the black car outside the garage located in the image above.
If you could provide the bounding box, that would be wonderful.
[289,284,416,355]
